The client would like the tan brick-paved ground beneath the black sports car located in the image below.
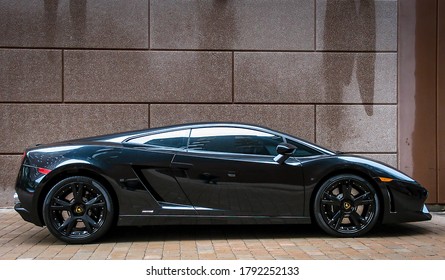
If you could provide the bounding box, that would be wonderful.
[0,209,445,260]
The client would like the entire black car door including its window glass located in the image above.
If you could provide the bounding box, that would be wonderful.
[172,127,304,217]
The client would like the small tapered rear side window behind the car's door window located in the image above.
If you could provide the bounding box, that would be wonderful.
[128,129,190,148]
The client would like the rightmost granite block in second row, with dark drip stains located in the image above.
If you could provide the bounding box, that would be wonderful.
[234,52,397,104]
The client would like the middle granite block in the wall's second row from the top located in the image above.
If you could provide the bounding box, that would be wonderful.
[64,51,232,103]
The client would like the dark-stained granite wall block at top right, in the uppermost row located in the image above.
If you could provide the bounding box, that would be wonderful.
[316,0,397,51]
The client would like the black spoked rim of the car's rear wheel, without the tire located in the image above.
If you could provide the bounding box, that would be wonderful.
[49,182,107,239]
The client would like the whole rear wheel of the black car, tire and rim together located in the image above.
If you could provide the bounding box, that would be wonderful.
[43,176,114,244]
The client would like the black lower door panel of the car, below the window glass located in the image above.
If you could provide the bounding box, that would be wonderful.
[172,152,304,217]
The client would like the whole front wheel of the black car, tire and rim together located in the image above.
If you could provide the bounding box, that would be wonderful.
[314,174,380,237]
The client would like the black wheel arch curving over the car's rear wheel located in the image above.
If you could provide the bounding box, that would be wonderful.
[37,164,119,225]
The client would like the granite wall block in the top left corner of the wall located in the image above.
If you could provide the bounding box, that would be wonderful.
[0,0,149,49]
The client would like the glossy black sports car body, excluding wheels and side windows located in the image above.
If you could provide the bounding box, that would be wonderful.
[15,123,431,236]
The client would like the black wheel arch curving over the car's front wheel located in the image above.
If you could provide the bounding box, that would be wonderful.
[309,168,385,223]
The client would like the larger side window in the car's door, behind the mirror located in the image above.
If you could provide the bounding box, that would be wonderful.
[188,127,283,155]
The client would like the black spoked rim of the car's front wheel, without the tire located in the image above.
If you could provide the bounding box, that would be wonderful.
[320,178,377,234]
